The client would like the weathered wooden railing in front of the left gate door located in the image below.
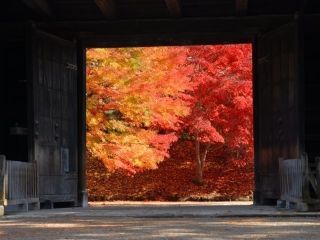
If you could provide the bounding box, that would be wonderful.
[0,155,39,210]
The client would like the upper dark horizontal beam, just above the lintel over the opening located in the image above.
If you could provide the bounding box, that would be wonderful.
[36,15,294,35]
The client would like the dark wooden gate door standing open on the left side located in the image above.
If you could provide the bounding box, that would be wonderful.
[31,31,78,206]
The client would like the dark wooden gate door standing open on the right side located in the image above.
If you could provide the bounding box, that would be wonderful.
[254,24,301,204]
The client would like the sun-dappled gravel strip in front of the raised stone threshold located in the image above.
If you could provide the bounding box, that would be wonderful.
[0,217,320,240]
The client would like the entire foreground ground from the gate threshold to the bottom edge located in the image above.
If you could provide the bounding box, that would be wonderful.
[0,203,320,240]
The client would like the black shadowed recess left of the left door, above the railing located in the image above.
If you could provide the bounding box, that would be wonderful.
[0,37,29,162]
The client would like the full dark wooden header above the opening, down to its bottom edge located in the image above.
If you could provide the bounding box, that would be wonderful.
[35,15,294,47]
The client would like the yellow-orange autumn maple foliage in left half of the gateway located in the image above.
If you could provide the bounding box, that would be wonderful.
[86,47,192,173]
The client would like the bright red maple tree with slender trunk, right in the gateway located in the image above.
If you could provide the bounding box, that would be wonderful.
[184,44,253,184]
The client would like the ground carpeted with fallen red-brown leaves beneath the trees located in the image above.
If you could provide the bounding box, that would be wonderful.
[87,141,253,201]
